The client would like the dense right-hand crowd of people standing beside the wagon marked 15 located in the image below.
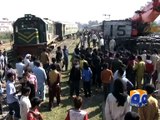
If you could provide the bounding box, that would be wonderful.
[69,29,160,120]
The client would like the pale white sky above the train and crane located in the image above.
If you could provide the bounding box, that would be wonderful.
[0,0,159,23]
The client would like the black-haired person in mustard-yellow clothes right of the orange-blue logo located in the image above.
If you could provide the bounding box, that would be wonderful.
[138,84,159,120]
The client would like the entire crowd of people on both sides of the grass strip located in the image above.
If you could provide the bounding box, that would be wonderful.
[0,29,160,120]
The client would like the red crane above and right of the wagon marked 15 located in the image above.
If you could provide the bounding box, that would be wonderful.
[131,0,160,36]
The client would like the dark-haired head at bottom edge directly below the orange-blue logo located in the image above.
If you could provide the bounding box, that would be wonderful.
[124,112,140,120]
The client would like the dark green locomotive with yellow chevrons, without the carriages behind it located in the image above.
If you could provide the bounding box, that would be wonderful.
[13,14,56,56]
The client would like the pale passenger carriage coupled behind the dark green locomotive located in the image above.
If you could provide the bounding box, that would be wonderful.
[55,22,78,40]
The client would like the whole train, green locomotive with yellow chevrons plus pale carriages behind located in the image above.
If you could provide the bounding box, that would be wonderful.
[13,14,78,56]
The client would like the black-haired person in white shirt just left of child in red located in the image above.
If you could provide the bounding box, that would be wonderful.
[20,87,31,120]
